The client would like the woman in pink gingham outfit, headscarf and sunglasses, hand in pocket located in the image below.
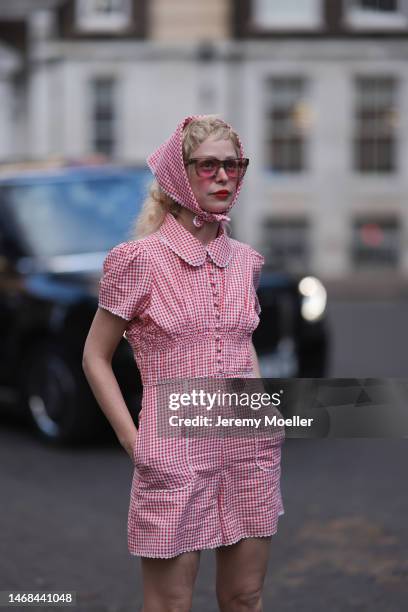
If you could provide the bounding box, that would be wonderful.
[84,115,284,612]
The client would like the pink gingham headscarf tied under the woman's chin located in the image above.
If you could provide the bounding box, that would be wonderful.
[147,115,244,227]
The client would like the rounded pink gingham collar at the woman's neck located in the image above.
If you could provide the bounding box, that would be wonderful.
[158,212,232,268]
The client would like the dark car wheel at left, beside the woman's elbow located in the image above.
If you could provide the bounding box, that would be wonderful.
[22,344,102,443]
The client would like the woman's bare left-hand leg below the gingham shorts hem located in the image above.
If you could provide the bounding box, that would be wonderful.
[141,550,200,612]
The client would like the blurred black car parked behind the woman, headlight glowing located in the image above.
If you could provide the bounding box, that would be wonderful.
[0,164,327,443]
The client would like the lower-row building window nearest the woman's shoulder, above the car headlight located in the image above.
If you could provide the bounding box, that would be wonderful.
[262,218,310,272]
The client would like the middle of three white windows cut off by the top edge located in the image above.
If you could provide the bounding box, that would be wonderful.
[251,0,322,30]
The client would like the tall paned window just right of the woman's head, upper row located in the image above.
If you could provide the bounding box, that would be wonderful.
[265,77,309,172]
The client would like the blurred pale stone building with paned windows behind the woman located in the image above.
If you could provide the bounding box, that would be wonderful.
[0,0,408,281]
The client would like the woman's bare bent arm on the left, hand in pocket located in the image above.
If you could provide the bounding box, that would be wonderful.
[82,308,137,458]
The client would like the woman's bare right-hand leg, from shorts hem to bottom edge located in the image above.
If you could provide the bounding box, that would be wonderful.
[216,536,272,612]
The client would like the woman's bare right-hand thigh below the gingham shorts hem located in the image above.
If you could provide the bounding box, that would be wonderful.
[216,536,272,600]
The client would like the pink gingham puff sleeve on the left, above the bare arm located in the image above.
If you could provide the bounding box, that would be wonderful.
[98,241,151,321]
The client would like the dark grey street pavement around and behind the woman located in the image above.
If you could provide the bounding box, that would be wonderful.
[0,302,408,612]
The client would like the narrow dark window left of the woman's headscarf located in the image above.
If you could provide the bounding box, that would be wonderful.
[92,78,116,156]
